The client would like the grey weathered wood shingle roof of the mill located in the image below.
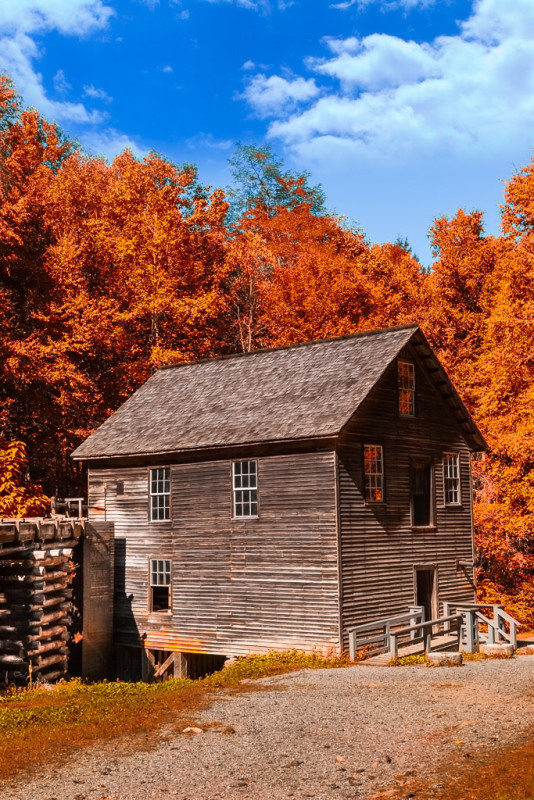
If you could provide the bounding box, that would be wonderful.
[73,325,483,460]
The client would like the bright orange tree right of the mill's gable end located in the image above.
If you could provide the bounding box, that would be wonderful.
[423,203,534,625]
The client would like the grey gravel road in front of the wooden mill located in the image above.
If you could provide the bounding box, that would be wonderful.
[4,656,534,800]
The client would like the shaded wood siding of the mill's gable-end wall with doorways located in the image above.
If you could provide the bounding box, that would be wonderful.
[338,348,474,646]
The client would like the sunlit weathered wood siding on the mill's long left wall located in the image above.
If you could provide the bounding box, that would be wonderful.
[89,451,339,655]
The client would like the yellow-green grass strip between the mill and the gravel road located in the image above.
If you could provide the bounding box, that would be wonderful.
[0,651,350,779]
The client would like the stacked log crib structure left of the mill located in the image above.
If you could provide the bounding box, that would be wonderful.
[0,518,85,685]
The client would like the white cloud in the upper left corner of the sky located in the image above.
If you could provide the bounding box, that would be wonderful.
[0,0,114,124]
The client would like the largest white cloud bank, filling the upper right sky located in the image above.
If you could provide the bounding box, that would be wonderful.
[253,0,534,160]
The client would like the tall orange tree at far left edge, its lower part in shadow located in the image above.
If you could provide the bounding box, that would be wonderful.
[0,80,77,494]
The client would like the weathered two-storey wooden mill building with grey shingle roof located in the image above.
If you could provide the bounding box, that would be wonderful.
[74,326,485,677]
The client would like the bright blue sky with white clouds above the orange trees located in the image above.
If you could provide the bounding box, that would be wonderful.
[0,0,534,264]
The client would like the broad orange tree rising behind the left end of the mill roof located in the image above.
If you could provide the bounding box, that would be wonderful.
[18,151,232,490]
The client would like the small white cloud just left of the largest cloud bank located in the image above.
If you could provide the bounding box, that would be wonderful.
[243,74,319,117]
